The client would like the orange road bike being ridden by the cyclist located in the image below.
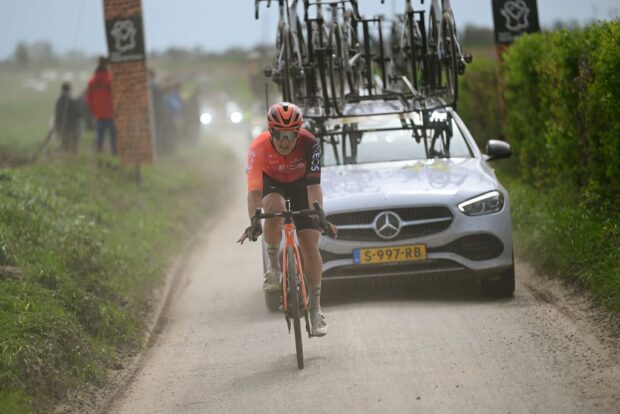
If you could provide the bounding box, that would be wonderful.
[250,198,329,369]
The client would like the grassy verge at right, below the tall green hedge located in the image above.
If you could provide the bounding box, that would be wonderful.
[500,168,620,312]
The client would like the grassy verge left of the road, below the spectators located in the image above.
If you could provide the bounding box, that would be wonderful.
[0,141,232,413]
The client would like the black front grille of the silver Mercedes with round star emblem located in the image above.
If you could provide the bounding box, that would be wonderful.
[327,206,453,241]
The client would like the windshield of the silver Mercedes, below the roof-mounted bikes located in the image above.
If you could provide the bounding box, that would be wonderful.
[323,112,473,166]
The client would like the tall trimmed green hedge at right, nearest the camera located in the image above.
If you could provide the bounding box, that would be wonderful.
[504,21,620,210]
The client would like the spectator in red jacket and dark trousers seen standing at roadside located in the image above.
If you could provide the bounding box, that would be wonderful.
[86,57,116,154]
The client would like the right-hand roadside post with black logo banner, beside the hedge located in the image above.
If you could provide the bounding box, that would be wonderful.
[491,0,540,138]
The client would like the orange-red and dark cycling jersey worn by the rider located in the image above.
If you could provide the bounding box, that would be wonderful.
[247,128,321,191]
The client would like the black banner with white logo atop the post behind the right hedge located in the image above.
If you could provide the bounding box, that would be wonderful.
[492,0,540,45]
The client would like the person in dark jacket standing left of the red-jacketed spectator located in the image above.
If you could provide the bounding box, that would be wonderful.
[54,82,81,153]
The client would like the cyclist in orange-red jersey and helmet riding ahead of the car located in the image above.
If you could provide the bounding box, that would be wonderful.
[238,102,337,336]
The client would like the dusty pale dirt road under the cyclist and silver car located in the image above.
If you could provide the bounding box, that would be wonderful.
[104,130,620,414]
